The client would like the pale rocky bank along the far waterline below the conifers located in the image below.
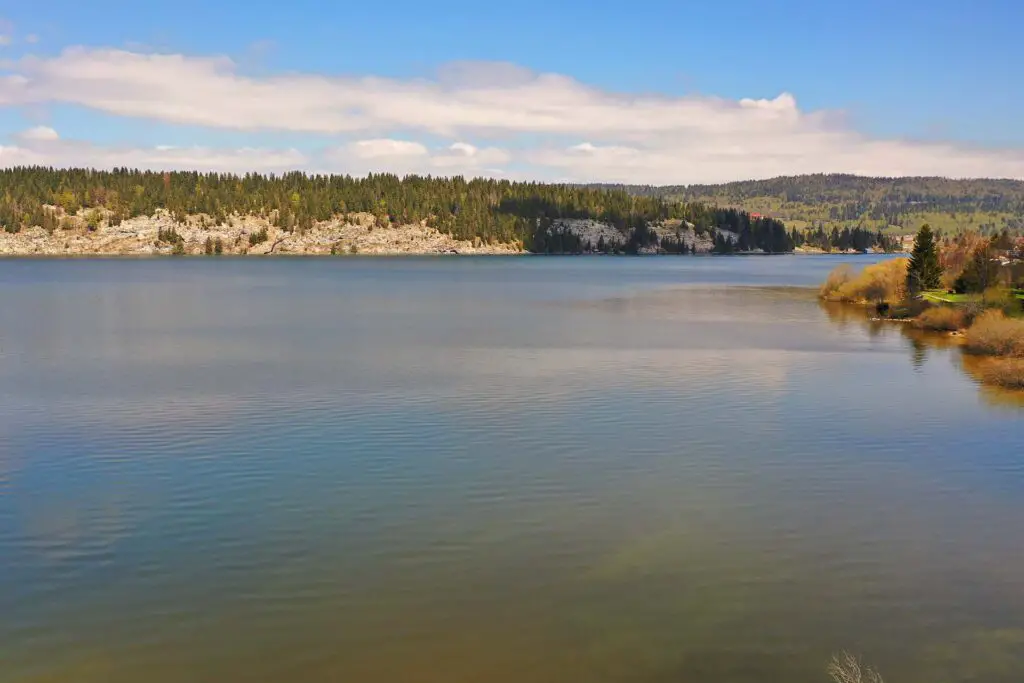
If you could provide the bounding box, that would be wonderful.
[0,207,905,259]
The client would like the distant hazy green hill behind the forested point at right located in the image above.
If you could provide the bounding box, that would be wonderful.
[598,174,1024,233]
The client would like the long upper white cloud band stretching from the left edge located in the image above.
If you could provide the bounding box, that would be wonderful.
[0,48,864,139]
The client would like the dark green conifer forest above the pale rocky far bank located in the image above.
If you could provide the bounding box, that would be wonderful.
[0,167,794,253]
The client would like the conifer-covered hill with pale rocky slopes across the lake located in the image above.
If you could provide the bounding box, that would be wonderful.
[0,167,794,254]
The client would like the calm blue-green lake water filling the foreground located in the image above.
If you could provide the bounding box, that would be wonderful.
[0,257,1024,683]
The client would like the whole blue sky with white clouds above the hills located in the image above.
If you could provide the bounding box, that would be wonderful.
[0,0,1024,184]
